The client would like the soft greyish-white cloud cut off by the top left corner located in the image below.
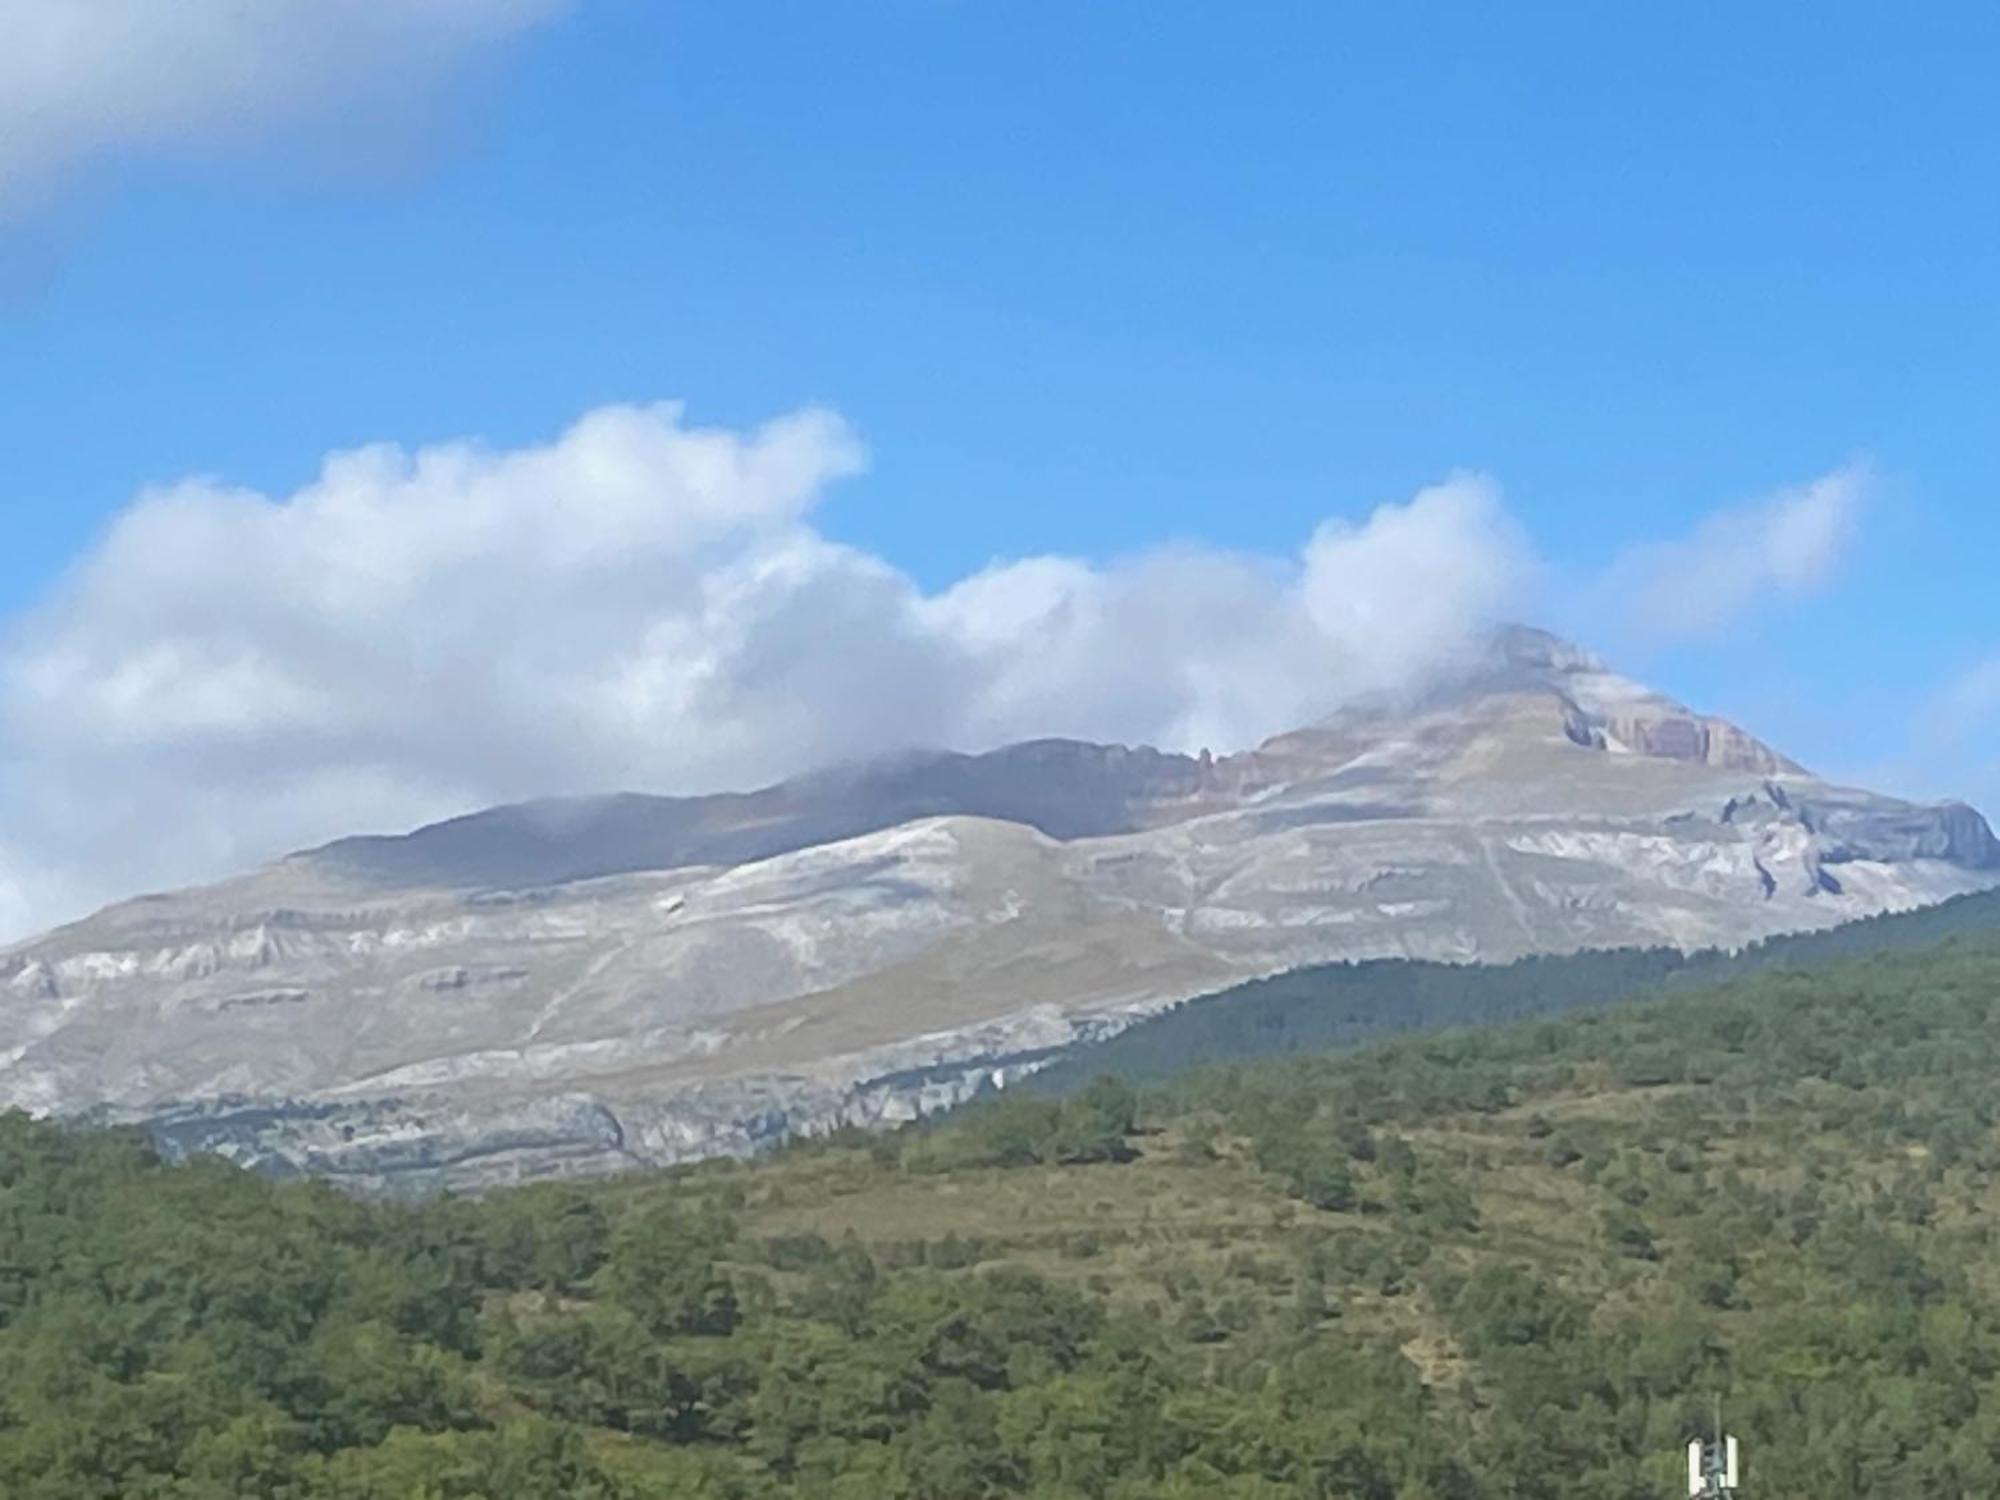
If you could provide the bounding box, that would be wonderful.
[0,0,570,216]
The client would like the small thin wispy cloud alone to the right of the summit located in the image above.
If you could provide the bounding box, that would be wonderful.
[1596,466,1868,640]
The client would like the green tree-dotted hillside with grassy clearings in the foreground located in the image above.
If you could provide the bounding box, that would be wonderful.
[0,936,2000,1500]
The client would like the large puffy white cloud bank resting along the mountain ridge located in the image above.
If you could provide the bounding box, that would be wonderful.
[0,406,1532,932]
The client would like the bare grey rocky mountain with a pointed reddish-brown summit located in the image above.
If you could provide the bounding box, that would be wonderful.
[0,628,2000,1186]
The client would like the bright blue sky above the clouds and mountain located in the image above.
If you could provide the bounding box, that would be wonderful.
[0,0,2000,940]
